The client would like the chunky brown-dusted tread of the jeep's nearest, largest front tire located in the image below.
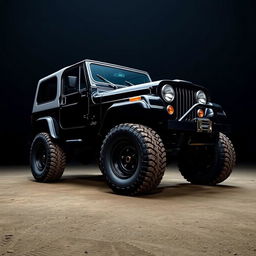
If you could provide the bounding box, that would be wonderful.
[99,123,166,195]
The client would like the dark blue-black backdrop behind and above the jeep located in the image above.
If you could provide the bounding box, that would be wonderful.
[0,0,256,164]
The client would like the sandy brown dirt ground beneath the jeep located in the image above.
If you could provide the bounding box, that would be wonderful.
[0,166,256,256]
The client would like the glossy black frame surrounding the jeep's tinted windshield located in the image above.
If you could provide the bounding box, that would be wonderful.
[85,60,152,88]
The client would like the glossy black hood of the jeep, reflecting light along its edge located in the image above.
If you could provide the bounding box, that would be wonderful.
[92,79,206,103]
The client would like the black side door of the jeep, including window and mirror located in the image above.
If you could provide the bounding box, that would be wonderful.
[59,65,89,129]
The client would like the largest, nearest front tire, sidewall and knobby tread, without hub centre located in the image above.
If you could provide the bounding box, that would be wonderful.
[99,123,166,195]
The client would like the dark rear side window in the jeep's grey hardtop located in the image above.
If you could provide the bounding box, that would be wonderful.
[36,77,57,104]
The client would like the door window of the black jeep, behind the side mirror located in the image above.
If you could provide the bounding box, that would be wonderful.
[62,67,79,94]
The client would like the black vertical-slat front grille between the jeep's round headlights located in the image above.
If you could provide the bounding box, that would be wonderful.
[175,87,196,121]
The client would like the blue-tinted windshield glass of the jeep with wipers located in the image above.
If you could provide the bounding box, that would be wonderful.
[90,64,150,86]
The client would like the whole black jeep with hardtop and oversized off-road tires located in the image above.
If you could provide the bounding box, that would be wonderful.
[30,60,235,195]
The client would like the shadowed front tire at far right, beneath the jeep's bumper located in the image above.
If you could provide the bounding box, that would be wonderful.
[178,133,236,185]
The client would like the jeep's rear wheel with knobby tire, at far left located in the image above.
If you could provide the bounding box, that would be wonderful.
[30,132,66,182]
